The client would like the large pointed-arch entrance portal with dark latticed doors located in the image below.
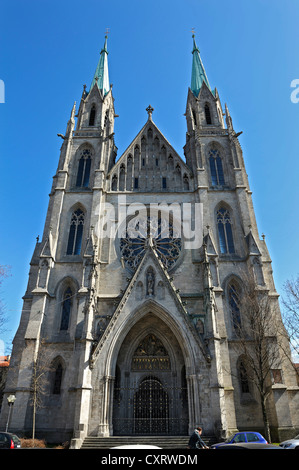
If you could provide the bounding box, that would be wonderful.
[112,313,188,435]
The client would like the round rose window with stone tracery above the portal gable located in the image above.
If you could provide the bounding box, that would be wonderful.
[119,215,182,271]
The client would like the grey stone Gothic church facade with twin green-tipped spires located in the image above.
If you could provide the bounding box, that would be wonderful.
[1,38,299,448]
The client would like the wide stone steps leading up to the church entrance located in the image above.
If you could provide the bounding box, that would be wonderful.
[81,436,216,449]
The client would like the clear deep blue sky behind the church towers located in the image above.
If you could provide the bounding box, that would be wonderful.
[0,0,299,351]
